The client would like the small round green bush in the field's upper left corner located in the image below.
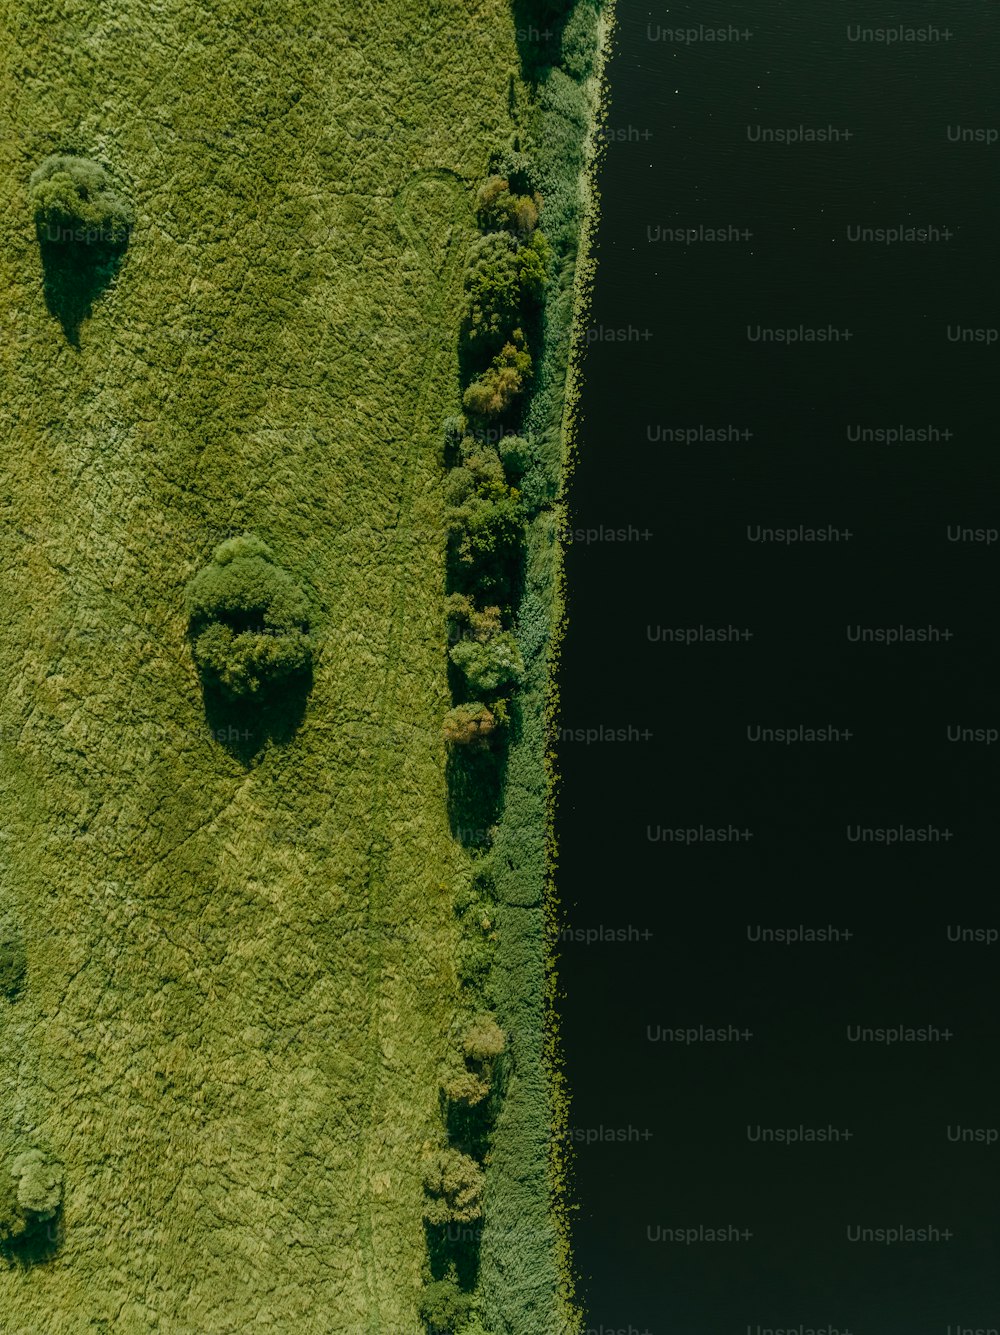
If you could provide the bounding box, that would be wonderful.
[29,154,134,250]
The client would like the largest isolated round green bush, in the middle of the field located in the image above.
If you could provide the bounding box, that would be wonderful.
[186,535,312,700]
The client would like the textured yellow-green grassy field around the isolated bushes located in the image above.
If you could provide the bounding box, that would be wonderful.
[0,0,603,1335]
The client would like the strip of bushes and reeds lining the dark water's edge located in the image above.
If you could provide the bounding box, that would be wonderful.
[437,0,613,1335]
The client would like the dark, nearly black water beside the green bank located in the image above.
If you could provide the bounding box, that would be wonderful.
[561,0,1000,1335]
